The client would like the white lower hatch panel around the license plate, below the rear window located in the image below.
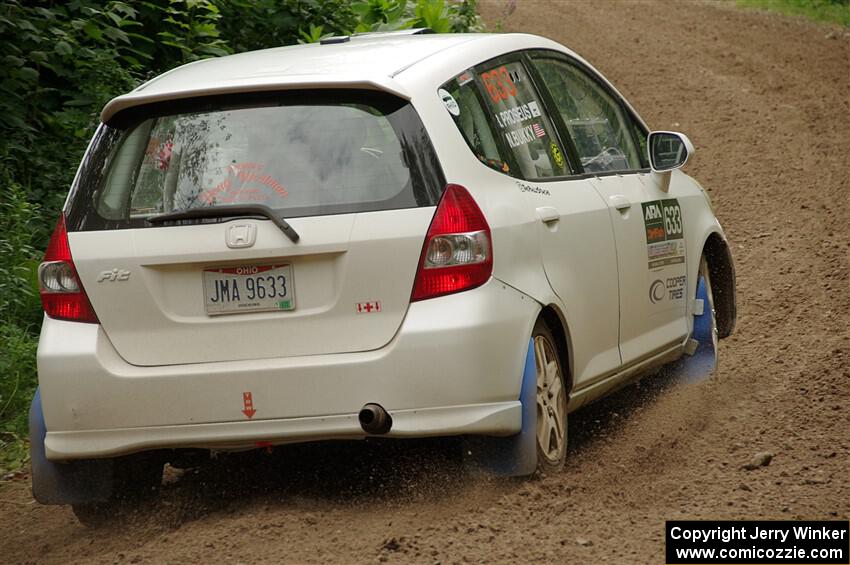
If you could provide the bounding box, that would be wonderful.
[69,207,434,365]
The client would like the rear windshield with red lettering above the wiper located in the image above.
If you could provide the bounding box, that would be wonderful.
[67,91,445,230]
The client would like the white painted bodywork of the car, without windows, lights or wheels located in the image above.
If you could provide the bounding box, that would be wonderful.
[38,34,722,460]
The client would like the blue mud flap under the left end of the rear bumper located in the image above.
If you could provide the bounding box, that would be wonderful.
[29,390,112,504]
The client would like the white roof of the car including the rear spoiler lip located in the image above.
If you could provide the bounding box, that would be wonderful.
[101,32,496,122]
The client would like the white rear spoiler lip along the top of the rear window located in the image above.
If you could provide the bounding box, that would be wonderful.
[100,75,410,123]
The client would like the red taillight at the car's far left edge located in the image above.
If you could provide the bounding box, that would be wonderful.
[38,216,97,324]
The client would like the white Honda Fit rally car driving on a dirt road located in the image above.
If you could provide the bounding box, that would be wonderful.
[31,31,735,523]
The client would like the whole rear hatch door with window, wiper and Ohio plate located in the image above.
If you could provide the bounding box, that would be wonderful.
[66,91,445,365]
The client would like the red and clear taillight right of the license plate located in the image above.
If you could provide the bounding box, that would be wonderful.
[411,184,493,302]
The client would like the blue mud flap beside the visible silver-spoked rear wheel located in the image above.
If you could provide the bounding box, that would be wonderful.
[463,340,537,477]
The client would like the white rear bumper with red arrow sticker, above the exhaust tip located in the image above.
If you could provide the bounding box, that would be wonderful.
[38,280,540,460]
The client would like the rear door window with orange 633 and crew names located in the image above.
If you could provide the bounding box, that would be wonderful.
[476,61,568,179]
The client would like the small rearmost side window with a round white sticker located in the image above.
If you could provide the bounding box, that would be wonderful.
[438,69,512,174]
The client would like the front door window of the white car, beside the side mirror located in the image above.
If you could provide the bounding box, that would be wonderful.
[534,59,643,173]
